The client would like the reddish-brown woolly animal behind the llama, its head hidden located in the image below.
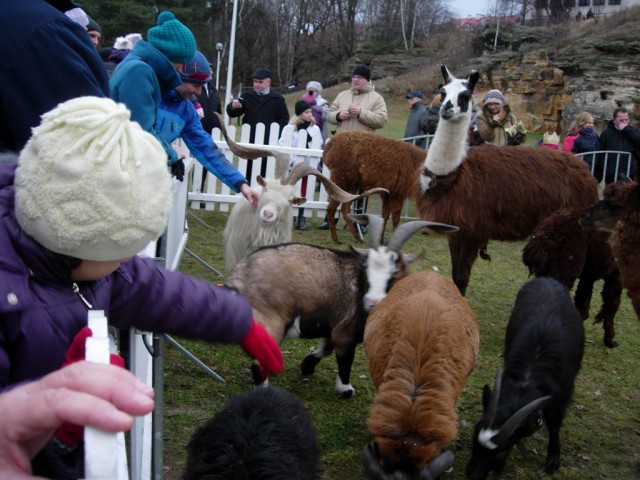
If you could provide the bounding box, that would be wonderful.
[322,132,425,243]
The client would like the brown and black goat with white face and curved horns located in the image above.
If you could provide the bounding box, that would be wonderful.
[226,214,457,398]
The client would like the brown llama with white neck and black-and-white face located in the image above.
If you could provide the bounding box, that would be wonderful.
[417,65,598,295]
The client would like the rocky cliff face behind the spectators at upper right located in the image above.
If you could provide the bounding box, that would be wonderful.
[468,8,640,133]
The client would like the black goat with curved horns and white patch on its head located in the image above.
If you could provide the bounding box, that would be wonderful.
[467,277,584,480]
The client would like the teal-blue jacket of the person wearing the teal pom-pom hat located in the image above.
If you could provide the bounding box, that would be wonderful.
[109,40,182,163]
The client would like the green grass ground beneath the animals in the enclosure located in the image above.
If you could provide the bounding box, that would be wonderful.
[159,89,640,480]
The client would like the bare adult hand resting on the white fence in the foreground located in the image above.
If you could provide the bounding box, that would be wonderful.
[0,361,154,480]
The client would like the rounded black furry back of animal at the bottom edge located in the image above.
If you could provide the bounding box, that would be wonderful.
[183,386,320,480]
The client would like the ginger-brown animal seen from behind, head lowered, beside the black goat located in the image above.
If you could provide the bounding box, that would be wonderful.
[363,271,480,479]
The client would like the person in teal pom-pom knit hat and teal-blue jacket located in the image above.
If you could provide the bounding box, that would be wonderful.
[109,11,196,176]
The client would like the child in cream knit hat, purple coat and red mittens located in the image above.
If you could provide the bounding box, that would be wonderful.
[0,97,283,479]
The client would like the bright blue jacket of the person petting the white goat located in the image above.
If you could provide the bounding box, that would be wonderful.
[157,90,245,192]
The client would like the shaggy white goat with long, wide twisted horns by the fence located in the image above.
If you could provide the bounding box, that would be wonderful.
[220,114,389,273]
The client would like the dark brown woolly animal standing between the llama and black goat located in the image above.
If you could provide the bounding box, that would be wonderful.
[522,207,622,348]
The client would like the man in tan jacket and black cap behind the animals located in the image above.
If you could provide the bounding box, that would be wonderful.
[327,65,387,132]
